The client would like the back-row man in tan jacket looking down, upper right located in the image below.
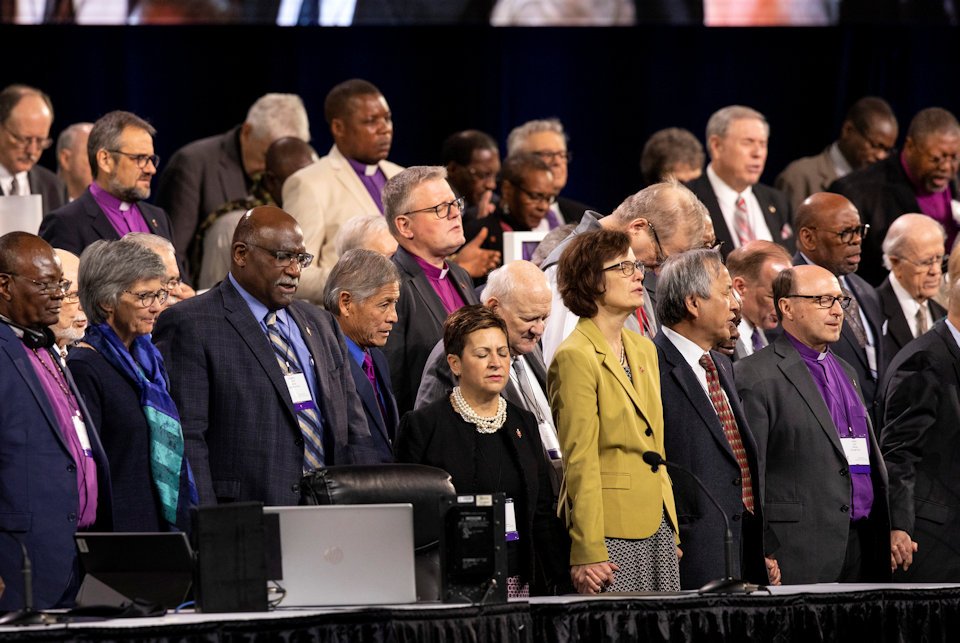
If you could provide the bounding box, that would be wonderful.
[774,96,899,209]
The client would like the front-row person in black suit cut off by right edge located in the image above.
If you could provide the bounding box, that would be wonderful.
[880,281,960,583]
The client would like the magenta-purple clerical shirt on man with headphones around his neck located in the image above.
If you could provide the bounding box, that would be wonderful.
[24,346,97,528]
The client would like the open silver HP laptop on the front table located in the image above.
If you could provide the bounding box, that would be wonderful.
[263,504,417,607]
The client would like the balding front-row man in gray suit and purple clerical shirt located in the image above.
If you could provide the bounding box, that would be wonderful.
[734,265,891,584]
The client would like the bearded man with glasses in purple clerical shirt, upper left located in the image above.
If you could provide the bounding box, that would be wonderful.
[40,110,183,280]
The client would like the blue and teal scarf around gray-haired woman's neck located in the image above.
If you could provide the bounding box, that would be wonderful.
[83,323,199,529]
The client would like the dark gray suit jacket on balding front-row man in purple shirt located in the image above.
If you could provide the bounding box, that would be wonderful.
[734,335,890,584]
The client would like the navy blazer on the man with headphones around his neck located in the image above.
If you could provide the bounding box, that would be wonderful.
[0,323,111,610]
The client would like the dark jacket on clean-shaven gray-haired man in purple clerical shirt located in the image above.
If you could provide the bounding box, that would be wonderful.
[384,246,480,417]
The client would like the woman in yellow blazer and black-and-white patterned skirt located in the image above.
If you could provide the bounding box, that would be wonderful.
[547,230,680,594]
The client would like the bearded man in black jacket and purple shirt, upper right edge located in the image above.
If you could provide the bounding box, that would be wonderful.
[829,107,960,286]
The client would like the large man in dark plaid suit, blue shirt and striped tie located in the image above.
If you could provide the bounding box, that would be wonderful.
[153,206,377,505]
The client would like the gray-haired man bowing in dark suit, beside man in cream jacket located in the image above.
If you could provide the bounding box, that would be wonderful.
[157,94,310,262]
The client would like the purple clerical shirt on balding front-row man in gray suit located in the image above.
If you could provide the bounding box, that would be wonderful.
[784,332,873,520]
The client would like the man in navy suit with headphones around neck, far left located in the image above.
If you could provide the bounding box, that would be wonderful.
[0,232,110,610]
